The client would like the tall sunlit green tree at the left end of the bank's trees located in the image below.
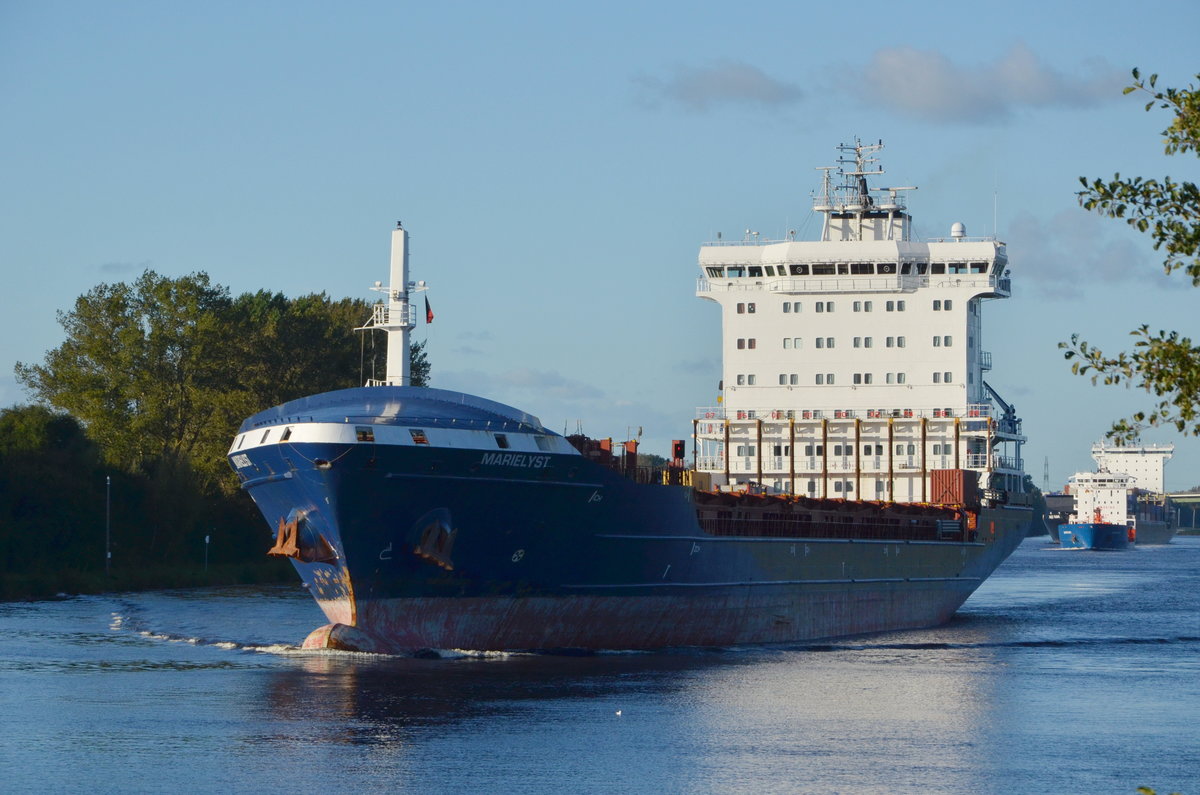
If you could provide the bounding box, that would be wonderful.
[16,270,230,485]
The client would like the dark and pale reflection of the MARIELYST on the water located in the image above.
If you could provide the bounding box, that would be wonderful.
[262,634,1003,791]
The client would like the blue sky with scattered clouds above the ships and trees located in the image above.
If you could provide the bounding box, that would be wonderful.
[0,0,1200,489]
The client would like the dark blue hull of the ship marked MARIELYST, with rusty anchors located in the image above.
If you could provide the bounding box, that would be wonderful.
[230,387,1031,652]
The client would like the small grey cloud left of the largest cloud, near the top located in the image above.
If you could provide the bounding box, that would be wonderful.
[634,60,803,113]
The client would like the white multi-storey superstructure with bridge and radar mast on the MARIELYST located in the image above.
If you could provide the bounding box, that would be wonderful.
[696,142,1025,502]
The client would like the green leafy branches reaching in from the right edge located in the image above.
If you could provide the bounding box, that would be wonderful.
[1058,70,1200,440]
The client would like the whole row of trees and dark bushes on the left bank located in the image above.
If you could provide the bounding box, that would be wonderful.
[0,270,430,598]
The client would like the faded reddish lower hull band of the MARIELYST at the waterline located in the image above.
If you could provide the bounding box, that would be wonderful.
[304,579,979,653]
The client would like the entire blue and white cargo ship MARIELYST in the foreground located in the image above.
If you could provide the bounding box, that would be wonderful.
[228,142,1032,653]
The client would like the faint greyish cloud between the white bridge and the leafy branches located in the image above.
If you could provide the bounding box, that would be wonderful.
[1006,209,1172,299]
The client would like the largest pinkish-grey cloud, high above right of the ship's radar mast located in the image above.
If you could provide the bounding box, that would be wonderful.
[856,43,1128,122]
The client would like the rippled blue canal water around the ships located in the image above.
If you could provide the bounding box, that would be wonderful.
[0,537,1200,794]
